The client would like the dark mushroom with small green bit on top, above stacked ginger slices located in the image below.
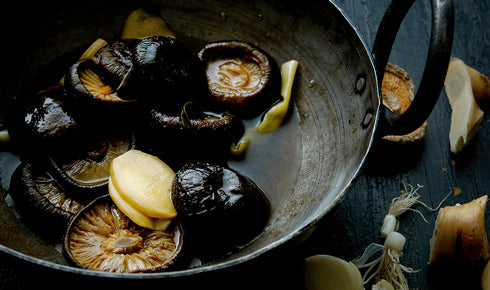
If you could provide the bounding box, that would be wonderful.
[137,103,244,165]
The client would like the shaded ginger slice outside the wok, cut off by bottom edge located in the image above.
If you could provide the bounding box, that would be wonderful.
[304,255,363,290]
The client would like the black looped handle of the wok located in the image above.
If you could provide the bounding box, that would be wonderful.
[372,0,454,137]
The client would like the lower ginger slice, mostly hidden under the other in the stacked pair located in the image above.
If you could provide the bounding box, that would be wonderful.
[109,178,172,231]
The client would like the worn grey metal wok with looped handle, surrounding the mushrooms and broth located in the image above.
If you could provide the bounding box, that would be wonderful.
[0,0,453,279]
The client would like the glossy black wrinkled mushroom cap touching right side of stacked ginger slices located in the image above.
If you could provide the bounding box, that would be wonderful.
[172,162,270,250]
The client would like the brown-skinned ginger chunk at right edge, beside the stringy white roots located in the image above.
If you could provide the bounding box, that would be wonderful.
[430,195,490,267]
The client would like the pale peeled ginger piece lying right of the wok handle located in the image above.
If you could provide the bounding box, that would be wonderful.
[444,58,483,153]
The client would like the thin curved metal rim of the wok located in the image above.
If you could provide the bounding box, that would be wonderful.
[0,0,381,280]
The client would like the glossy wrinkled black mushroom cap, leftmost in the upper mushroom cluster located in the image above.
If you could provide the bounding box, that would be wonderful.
[8,86,81,156]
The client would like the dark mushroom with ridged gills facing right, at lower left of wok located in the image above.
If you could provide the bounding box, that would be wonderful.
[10,163,83,241]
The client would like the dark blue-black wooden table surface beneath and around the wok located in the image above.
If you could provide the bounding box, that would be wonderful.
[0,0,490,289]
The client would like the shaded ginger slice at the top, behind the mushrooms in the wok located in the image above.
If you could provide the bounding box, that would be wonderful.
[121,8,175,39]
